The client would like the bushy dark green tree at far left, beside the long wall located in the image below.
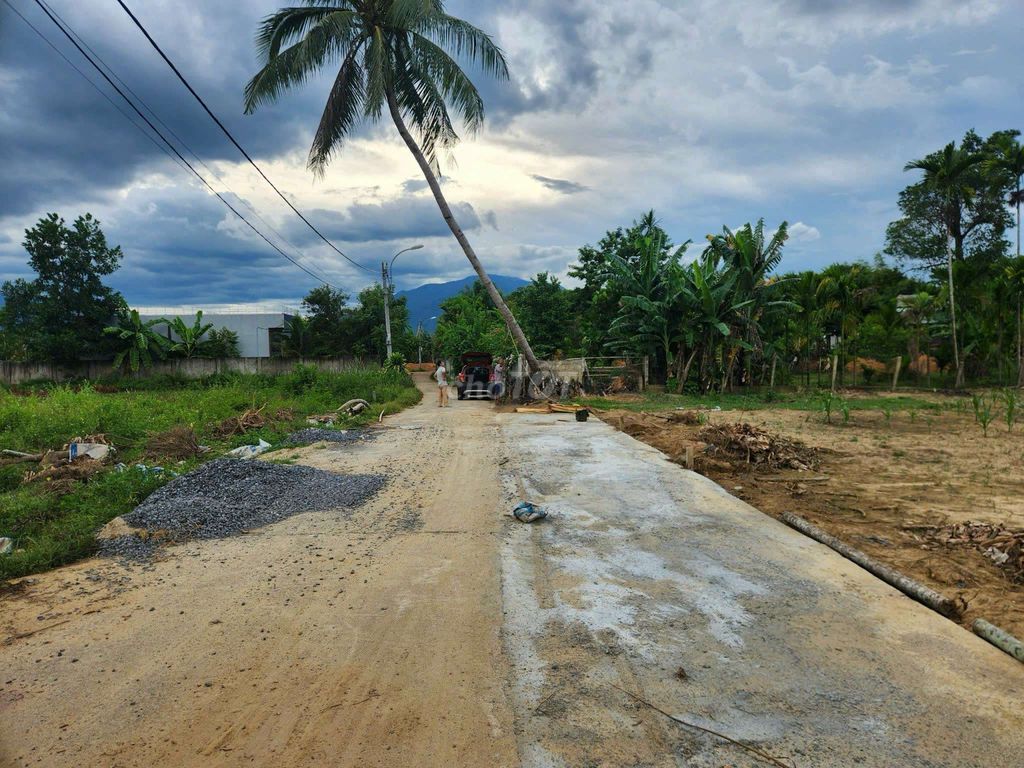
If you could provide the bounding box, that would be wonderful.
[0,213,124,362]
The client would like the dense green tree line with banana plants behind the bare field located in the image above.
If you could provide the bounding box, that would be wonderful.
[433,131,1024,392]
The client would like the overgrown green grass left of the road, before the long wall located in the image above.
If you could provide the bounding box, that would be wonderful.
[0,366,421,580]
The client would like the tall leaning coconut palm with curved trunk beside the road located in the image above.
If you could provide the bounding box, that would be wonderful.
[245,0,541,371]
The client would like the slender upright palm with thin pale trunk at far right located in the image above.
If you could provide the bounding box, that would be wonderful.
[903,141,984,387]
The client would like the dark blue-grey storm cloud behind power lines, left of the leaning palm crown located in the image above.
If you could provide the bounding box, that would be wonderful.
[0,0,335,215]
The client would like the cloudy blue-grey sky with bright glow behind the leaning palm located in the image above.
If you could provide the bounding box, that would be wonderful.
[0,0,1024,306]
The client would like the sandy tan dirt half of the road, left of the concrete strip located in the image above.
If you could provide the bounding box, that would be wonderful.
[0,384,517,767]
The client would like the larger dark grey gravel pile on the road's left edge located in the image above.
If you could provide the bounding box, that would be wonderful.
[100,459,384,559]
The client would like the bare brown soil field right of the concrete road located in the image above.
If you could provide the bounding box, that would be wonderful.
[601,396,1024,637]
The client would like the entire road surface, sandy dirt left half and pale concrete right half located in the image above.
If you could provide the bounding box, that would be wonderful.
[0,382,1024,768]
